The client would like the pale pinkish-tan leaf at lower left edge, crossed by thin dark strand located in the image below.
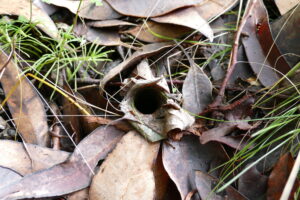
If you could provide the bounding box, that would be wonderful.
[0,140,70,176]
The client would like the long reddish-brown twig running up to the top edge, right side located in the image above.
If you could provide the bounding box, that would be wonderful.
[209,0,257,107]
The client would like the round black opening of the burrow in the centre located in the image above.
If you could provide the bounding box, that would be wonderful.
[134,87,164,114]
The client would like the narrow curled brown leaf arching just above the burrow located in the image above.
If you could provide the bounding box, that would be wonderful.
[100,43,173,93]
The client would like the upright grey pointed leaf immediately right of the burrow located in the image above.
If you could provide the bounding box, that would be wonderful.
[182,59,212,114]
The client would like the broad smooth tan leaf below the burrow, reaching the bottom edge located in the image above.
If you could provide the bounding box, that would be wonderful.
[90,131,160,200]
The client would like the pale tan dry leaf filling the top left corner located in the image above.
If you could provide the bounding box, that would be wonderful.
[0,0,59,38]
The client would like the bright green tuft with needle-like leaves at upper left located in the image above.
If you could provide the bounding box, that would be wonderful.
[0,18,113,91]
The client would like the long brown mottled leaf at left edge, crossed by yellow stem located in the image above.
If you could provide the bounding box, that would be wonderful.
[0,51,50,146]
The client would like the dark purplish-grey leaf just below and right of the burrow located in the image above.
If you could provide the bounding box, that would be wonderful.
[163,135,226,199]
